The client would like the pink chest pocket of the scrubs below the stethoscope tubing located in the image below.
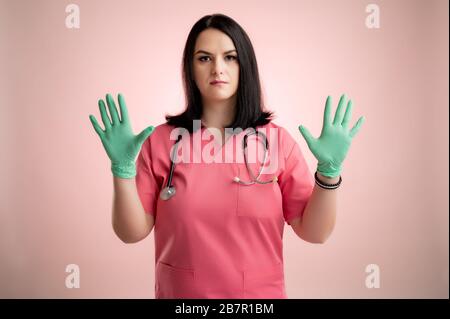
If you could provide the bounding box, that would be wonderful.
[236,164,283,218]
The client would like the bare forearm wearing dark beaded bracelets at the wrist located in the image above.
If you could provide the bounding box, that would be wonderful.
[300,173,339,243]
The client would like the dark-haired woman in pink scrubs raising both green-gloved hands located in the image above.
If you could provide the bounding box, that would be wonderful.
[90,14,363,298]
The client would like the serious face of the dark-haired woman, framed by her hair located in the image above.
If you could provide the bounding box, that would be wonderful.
[193,29,239,102]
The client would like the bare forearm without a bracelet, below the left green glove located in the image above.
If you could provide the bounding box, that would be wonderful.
[112,177,148,243]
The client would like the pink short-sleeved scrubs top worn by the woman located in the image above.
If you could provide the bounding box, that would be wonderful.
[136,122,314,299]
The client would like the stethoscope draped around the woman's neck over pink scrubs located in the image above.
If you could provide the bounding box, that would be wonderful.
[159,130,278,200]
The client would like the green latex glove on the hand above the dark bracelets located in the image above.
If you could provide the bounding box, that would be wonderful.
[298,94,364,177]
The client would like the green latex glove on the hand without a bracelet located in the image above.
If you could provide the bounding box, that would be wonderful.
[89,94,154,178]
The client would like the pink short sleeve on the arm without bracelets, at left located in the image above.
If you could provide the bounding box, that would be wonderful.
[136,137,159,216]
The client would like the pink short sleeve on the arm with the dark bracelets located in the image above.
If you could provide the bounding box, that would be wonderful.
[279,139,314,225]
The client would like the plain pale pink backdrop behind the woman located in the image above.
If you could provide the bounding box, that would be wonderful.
[0,0,449,298]
